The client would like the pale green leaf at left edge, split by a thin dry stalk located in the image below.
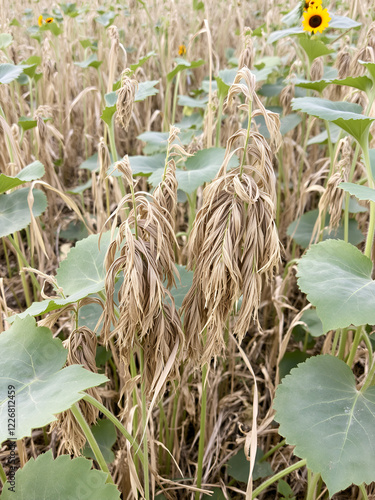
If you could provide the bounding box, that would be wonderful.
[0,188,47,237]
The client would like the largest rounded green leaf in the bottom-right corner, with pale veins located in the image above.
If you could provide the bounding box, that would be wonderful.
[274,355,375,496]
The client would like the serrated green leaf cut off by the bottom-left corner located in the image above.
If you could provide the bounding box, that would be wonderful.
[1,450,120,500]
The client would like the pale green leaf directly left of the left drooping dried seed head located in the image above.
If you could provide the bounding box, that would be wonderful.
[56,231,111,296]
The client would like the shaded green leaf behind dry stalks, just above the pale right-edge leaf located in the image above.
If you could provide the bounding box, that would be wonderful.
[287,210,363,248]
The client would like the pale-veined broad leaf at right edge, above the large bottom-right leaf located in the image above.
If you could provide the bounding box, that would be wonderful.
[297,240,375,332]
